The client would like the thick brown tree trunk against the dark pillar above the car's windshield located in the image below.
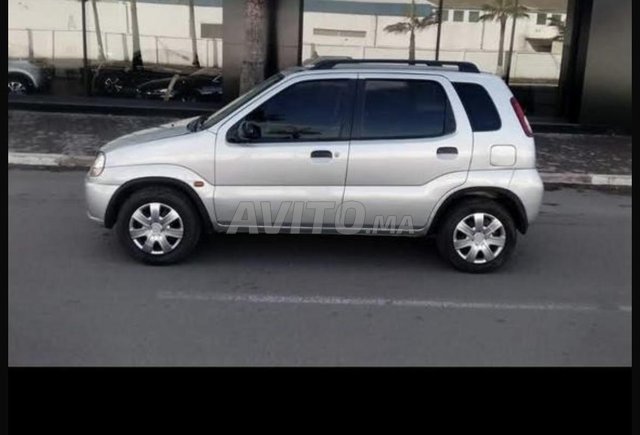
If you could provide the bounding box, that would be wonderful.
[240,0,267,94]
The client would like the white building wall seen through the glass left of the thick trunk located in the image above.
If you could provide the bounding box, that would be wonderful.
[8,0,222,66]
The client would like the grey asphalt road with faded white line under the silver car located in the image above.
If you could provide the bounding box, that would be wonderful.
[8,169,632,366]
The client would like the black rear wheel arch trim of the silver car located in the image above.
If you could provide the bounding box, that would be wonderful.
[427,187,529,235]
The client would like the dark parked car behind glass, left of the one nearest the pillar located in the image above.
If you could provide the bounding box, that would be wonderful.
[92,62,194,98]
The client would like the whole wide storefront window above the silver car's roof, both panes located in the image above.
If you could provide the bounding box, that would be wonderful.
[302,0,567,116]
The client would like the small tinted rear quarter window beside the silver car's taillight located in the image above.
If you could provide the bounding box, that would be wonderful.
[453,83,502,131]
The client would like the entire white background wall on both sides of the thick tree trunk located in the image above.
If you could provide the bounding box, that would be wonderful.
[8,0,562,80]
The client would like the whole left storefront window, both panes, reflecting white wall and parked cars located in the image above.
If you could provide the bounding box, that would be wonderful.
[9,0,222,102]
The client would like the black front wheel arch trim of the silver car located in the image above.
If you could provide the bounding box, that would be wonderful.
[104,177,213,233]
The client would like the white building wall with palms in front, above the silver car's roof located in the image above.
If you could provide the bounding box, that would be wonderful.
[302,11,562,81]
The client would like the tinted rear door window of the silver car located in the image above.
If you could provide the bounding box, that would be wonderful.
[359,80,455,139]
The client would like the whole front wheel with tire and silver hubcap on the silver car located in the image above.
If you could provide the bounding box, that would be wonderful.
[115,187,202,265]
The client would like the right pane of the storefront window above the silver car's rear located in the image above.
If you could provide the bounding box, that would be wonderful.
[440,0,567,117]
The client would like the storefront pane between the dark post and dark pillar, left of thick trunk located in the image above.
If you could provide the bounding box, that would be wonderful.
[85,0,222,102]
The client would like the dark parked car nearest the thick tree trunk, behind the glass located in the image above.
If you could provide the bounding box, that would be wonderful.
[137,68,222,102]
